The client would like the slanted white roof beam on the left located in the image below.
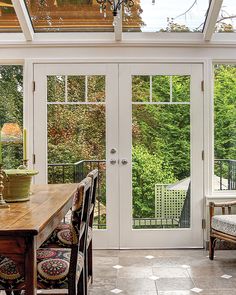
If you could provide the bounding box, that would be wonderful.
[12,0,34,41]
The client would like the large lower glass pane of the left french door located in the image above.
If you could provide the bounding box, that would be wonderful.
[47,104,106,229]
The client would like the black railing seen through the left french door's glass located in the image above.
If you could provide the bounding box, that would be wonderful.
[48,160,106,229]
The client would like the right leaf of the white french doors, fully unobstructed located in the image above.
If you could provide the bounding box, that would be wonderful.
[119,64,203,248]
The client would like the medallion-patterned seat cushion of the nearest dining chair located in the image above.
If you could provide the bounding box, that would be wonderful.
[0,248,84,289]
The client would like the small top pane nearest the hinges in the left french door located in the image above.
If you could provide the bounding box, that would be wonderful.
[47,76,65,102]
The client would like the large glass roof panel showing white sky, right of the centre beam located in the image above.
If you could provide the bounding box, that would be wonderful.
[123,0,209,32]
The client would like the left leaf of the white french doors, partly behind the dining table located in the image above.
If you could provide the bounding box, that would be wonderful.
[34,64,119,248]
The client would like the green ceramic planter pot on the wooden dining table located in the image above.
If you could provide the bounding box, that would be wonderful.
[3,169,38,202]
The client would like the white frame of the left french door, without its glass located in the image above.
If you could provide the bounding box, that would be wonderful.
[33,64,119,249]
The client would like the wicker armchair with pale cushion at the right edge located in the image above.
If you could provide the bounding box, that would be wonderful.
[209,201,236,260]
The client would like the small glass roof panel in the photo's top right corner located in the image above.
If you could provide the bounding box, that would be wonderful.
[216,0,236,33]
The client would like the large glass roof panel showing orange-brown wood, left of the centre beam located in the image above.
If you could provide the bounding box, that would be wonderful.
[25,0,114,32]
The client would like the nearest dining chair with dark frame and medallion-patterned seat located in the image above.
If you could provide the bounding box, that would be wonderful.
[0,177,92,295]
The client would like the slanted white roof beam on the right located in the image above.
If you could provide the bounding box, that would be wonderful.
[203,0,223,41]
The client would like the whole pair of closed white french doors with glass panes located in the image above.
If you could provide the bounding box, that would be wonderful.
[34,64,203,248]
